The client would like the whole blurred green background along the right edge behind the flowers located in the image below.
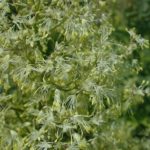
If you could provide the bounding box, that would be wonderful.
[104,0,150,149]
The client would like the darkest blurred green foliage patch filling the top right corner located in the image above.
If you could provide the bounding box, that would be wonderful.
[125,0,150,36]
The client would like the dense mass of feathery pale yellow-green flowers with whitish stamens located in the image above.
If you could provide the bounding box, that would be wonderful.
[0,0,150,150]
